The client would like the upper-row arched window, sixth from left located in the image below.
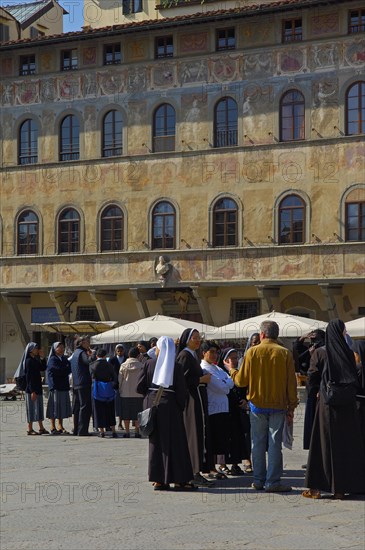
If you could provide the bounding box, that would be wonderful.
[280,90,305,141]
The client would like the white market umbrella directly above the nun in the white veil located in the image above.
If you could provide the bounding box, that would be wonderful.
[91,314,219,344]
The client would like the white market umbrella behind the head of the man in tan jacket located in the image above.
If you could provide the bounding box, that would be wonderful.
[216,311,327,340]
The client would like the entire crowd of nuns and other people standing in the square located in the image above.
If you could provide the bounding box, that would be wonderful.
[17,319,365,498]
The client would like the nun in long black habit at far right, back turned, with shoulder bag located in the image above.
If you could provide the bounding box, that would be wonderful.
[302,319,365,499]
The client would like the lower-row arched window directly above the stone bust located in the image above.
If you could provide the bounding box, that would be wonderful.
[152,202,176,248]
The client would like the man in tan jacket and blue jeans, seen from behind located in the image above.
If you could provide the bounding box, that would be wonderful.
[230,321,298,493]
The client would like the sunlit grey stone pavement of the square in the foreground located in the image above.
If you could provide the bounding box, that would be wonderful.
[0,401,365,550]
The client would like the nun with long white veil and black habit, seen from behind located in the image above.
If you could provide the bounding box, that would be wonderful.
[137,336,196,491]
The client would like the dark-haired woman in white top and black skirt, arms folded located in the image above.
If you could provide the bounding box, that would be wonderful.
[200,340,233,479]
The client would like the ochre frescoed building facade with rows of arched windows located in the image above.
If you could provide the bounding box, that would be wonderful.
[0,0,365,376]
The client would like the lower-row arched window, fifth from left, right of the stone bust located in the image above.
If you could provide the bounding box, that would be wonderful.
[213,198,238,246]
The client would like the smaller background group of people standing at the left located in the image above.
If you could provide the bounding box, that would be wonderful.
[19,336,148,438]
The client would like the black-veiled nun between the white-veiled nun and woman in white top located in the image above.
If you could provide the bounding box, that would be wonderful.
[177,328,215,486]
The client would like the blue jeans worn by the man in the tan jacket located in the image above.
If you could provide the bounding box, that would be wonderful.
[250,411,285,489]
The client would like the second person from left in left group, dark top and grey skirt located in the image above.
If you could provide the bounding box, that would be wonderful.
[46,342,72,435]
